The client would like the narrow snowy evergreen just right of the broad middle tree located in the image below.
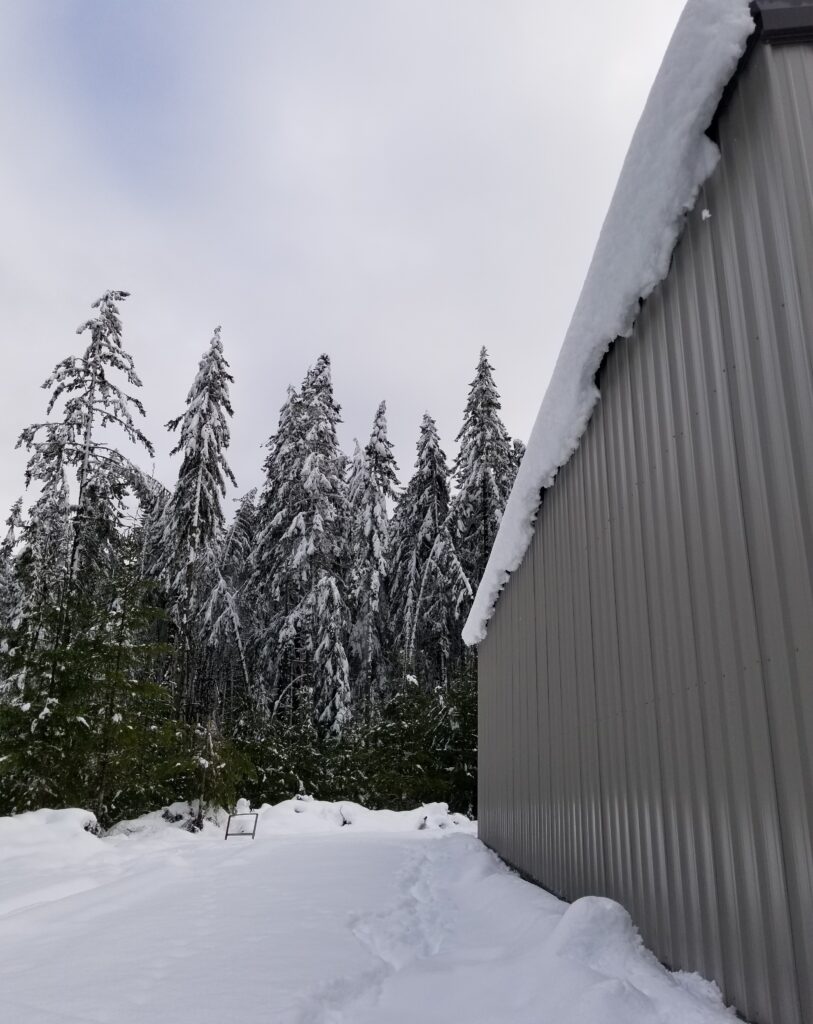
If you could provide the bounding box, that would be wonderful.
[349,401,398,702]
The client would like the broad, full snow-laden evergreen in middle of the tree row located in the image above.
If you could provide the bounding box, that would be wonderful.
[252,355,349,734]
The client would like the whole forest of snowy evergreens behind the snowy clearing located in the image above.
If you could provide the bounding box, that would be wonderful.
[0,292,523,824]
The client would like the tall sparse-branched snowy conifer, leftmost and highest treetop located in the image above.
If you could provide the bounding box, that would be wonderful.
[15,291,153,663]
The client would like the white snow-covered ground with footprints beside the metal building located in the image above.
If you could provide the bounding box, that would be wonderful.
[0,801,732,1024]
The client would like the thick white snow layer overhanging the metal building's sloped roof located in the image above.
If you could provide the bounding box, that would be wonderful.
[463,0,755,645]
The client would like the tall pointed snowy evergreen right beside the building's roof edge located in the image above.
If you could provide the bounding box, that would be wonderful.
[453,347,521,588]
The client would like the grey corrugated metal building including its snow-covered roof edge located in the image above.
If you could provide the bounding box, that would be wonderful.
[464,0,813,1024]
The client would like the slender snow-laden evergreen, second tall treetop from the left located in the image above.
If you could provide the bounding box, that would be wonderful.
[158,327,236,716]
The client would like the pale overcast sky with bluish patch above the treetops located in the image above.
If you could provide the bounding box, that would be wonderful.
[0,0,683,518]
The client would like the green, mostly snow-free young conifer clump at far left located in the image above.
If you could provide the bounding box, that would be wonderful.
[0,530,183,824]
